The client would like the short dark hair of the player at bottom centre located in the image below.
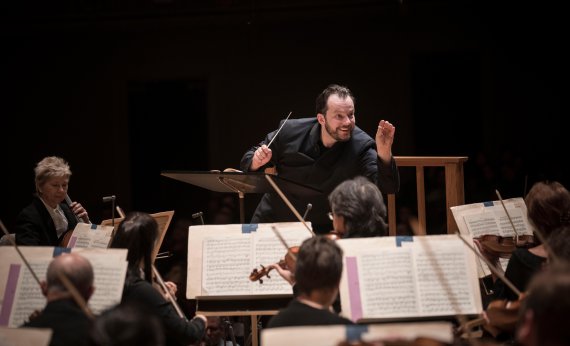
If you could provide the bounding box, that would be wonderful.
[295,235,342,294]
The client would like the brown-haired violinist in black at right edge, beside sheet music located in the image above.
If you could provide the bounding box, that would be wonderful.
[474,181,570,301]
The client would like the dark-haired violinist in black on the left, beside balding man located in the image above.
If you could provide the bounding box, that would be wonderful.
[110,212,206,345]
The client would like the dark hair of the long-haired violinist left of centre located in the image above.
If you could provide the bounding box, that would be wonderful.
[110,211,158,282]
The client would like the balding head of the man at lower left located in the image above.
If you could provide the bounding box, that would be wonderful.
[46,253,93,300]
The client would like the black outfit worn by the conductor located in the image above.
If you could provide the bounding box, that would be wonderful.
[240,117,400,233]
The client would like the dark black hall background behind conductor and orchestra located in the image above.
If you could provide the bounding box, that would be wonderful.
[0,0,569,235]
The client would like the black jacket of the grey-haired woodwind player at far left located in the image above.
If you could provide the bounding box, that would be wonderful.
[15,196,77,246]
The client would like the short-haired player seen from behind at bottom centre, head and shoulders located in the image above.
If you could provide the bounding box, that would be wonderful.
[267,236,353,328]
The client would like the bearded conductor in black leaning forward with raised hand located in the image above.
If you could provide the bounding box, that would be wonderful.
[240,84,400,233]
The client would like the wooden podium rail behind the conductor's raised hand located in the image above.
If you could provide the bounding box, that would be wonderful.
[388,156,467,236]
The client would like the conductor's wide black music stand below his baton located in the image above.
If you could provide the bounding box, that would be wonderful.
[161,171,322,224]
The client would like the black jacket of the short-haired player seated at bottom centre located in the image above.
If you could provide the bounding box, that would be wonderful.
[267,299,354,328]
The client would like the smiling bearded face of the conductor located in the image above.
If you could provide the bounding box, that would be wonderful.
[317,95,356,146]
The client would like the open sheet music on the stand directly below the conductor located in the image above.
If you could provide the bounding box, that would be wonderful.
[186,222,311,299]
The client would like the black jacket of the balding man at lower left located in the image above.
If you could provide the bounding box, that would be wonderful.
[23,299,91,346]
